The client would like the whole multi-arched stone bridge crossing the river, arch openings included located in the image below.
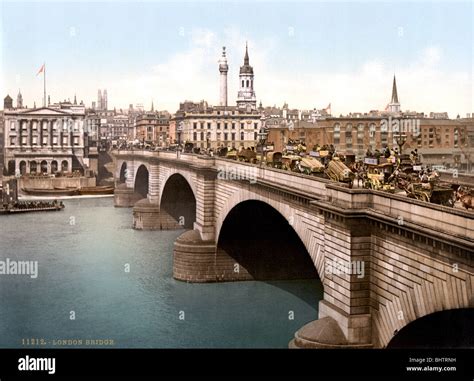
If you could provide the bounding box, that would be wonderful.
[114,151,474,348]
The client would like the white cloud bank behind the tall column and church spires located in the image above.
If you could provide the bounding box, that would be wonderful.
[105,33,472,118]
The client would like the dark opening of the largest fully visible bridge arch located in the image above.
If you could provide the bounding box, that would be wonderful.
[216,199,321,280]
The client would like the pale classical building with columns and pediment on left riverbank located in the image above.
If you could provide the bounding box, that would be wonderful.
[4,105,89,175]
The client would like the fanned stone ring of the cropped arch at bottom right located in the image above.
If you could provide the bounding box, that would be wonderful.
[373,274,474,347]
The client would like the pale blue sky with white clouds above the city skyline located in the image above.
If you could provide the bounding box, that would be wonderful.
[0,0,474,118]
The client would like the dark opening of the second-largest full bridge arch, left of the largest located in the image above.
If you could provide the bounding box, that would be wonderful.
[160,173,196,229]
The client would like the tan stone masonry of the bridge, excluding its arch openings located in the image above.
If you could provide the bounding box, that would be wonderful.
[115,148,474,348]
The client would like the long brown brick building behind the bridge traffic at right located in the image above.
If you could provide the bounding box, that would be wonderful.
[266,115,474,169]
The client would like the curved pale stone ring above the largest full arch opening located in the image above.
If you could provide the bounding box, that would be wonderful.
[215,189,324,282]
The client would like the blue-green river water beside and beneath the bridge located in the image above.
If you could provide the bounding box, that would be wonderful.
[0,198,323,348]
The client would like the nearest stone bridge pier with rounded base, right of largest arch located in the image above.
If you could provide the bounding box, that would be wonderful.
[290,212,372,348]
